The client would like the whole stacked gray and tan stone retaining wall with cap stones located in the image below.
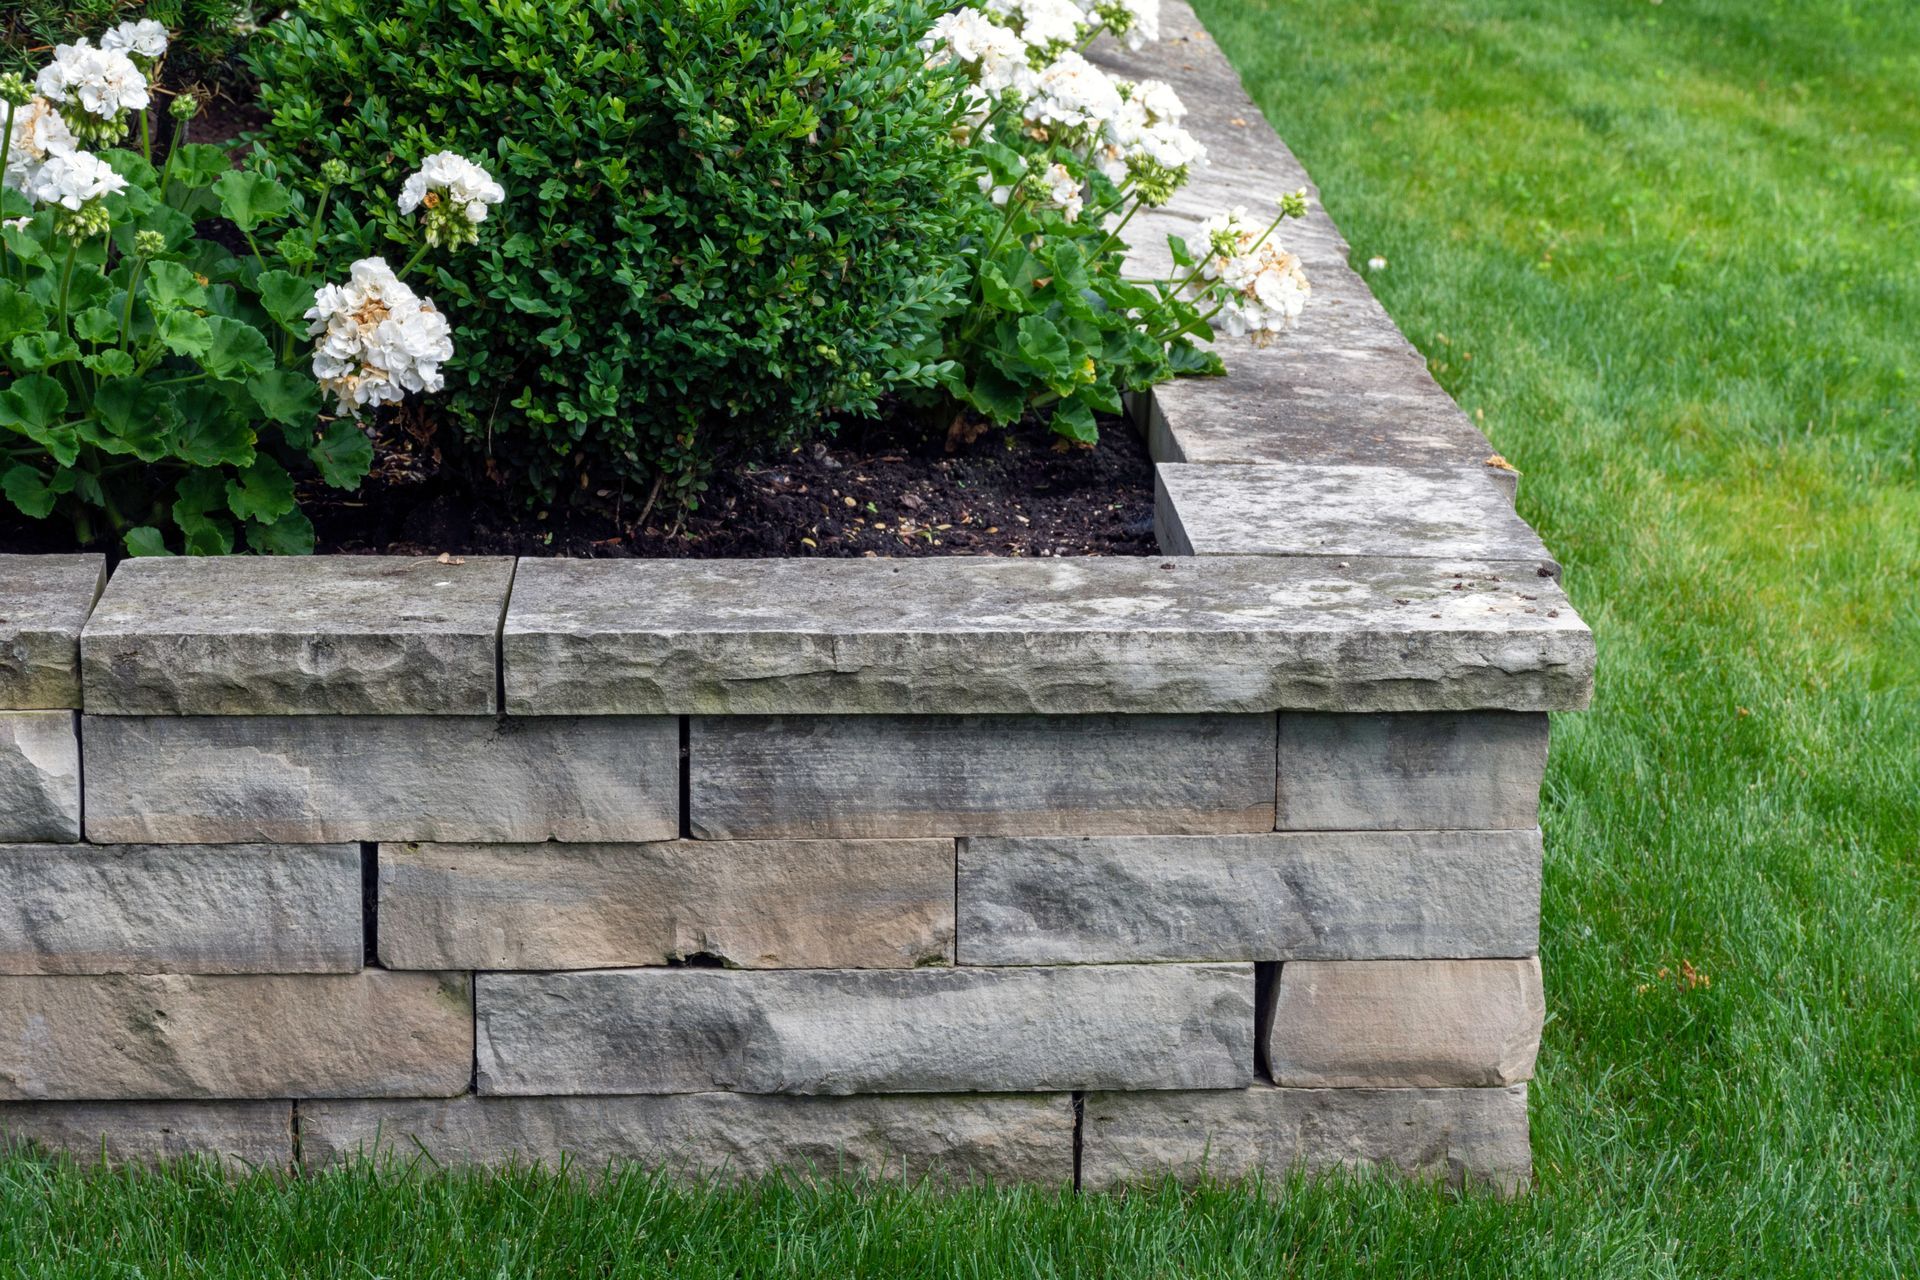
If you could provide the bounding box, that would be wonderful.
[0,6,1594,1190]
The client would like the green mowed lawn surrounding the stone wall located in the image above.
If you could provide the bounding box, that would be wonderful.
[0,0,1920,1280]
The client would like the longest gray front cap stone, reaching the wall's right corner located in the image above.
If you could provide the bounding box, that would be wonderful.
[501,560,1594,716]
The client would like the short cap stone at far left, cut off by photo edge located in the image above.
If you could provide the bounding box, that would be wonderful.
[0,555,108,710]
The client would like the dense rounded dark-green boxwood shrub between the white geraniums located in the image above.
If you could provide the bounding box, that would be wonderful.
[253,0,962,509]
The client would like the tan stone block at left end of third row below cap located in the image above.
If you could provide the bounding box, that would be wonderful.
[0,969,472,1102]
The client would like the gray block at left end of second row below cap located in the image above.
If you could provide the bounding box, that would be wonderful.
[0,844,360,973]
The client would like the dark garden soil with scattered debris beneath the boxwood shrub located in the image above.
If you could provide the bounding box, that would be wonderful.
[300,415,1158,558]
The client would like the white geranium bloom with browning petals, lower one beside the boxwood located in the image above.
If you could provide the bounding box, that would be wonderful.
[305,257,453,416]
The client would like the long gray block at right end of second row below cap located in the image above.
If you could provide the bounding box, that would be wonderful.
[958,831,1540,965]
